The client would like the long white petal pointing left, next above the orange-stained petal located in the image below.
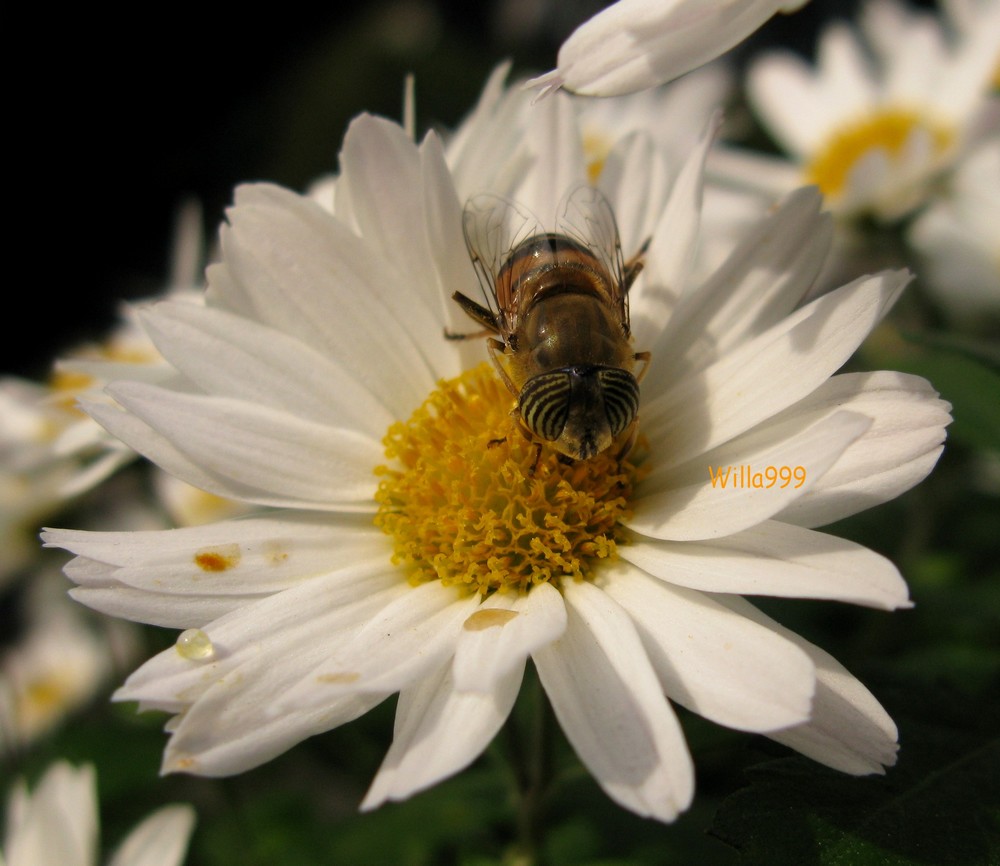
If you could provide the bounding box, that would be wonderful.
[103,382,385,509]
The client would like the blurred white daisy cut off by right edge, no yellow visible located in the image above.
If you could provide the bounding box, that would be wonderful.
[907,141,1000,327]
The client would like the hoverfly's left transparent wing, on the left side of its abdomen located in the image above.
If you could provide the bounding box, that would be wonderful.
[462,193,544,338]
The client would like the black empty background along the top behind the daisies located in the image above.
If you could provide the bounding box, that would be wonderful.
[7,0,916,377]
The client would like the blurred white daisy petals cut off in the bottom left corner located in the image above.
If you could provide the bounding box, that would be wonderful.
[0,761,195,866]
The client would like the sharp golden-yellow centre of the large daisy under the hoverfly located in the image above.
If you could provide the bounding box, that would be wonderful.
[375,364,636,595]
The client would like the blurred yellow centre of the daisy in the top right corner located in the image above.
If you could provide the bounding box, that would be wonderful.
[806,109,954,196]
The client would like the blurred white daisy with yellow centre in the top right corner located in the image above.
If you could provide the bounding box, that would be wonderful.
[713,0,1000,220]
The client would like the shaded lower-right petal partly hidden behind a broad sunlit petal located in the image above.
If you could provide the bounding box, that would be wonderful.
[723,597,899,776]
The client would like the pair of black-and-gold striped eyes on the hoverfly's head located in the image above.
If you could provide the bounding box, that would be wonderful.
[518,366,639,442]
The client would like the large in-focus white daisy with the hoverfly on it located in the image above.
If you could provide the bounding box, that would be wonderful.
[46,94,949,821]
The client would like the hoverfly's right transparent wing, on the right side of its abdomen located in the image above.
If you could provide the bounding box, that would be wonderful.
[555,186,628,328]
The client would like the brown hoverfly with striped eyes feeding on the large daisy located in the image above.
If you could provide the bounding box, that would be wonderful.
[448,187,650,460]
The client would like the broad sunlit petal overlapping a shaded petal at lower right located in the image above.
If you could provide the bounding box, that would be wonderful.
[602,565,815,732]
